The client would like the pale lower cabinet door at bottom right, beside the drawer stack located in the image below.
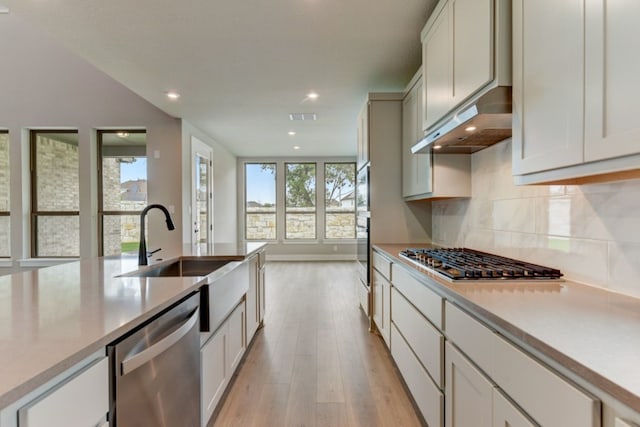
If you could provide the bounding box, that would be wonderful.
[445,342,493,427]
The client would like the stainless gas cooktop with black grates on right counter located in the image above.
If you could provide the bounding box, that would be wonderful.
[399,248,562,282]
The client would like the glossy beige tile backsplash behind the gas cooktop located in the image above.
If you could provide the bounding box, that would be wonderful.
[432,140,640,297]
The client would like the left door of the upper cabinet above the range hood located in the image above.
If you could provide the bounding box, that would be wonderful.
[422,4,452,130]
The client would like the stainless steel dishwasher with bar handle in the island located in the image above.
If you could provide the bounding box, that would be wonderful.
[107,294,200,427]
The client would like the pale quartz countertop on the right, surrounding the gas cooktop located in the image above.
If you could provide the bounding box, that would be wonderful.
[375,244,640,412]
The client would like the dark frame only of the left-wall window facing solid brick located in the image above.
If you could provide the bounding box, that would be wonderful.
[29,129,80,258]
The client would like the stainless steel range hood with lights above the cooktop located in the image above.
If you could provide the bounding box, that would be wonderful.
[411,86,511,154]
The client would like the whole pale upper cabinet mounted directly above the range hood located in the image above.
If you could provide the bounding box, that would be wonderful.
[421,0,511,130]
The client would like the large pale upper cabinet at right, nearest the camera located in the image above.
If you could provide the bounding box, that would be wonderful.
[513,0,640,184]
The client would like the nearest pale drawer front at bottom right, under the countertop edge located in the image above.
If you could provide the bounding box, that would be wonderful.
[493,337,601,427]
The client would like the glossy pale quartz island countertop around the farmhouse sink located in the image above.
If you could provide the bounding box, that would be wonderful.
[0,242,266,409]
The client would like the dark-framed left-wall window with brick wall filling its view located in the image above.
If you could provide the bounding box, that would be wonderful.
[31,130,80,257]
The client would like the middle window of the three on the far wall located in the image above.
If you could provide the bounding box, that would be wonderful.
[285,163,316,239]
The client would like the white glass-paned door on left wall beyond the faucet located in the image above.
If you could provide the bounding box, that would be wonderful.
[191,137,213,244]
